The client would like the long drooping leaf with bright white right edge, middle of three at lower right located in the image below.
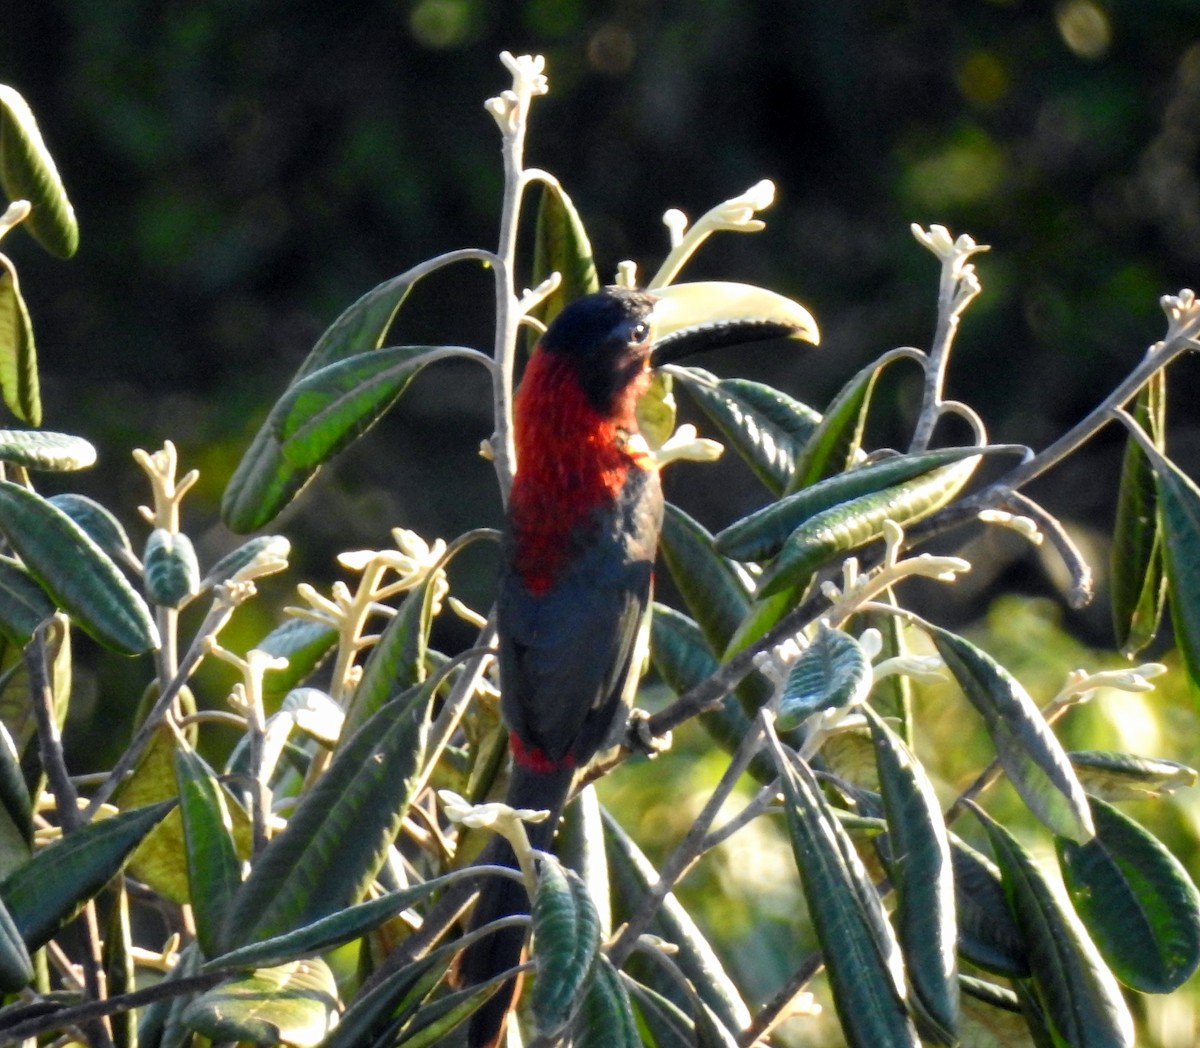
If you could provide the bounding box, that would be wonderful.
[863,706,959,1044]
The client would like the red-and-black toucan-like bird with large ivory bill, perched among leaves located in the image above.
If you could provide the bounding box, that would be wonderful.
[458,282,818,1048]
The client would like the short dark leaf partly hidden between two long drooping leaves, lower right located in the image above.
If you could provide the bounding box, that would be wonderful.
[950,834,1030,978]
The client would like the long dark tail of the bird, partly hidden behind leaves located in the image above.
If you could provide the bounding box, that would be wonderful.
[458,763,574,1048]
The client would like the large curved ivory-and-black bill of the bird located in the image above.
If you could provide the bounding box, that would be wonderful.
[650,281,821,367]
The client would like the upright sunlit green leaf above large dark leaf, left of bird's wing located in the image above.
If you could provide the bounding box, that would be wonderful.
[346,564,437,732]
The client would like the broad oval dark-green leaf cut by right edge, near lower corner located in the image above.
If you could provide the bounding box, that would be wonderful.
[1057,797,1200,994]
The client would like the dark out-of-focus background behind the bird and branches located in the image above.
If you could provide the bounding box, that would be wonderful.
[0,0,1200,1044]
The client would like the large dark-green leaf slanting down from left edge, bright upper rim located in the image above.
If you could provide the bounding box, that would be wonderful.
[0,480,158,655]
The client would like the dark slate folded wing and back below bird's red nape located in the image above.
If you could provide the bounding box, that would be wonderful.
[497,469,662,765]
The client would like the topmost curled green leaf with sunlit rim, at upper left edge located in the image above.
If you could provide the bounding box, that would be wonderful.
[0,84,79,258]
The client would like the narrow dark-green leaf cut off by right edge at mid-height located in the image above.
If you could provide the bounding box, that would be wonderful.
[1151,444,1200,691]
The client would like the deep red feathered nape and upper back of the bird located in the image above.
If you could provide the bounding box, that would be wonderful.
[510,349,650,593]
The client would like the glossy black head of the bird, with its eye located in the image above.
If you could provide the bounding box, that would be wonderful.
[541,287,655,414]
